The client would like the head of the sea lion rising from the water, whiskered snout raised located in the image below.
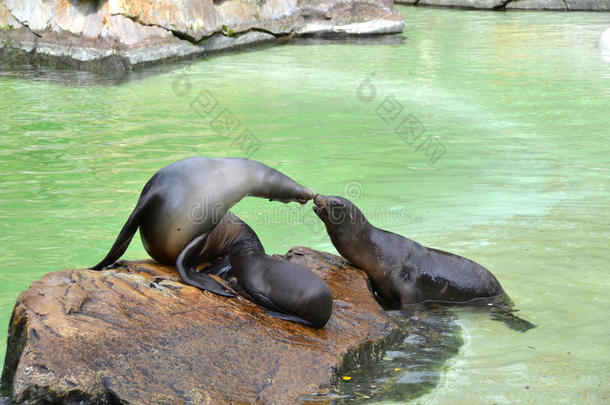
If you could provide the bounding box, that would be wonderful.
[313,194,368,233]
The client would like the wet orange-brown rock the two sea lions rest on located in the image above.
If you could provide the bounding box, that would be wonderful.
[2,247,402,404]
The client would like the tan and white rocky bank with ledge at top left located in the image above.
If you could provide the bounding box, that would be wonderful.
[0,0,404,72]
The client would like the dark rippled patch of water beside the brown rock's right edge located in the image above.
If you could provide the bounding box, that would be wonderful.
[297,305,463,404]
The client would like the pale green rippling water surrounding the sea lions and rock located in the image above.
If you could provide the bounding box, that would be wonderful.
[0,7,610,404]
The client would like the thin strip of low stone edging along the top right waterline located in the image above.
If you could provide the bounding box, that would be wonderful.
[394,0,610,11]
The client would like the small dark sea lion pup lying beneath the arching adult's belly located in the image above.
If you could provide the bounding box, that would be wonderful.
[193,211,333,328]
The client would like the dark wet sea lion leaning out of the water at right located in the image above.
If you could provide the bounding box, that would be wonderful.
[314,194,534,331]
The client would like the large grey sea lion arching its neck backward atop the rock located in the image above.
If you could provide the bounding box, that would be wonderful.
[91,157,313,296]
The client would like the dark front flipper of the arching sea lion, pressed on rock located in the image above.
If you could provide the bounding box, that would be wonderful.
[176,233,235,297]
